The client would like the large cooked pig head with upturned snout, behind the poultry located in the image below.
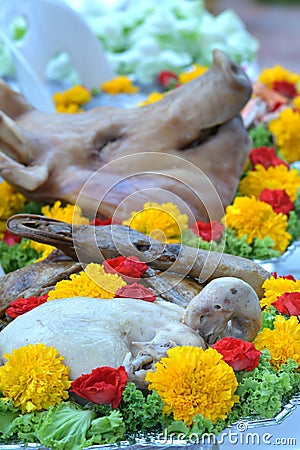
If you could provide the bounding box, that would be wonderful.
[0,50,252,220]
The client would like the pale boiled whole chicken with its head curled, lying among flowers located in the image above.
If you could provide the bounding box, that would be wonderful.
[0,277,261,386]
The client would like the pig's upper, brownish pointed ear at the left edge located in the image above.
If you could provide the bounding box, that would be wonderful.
[0,80,34,119]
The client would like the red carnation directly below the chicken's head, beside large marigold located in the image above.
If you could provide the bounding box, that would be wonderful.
[212,337,261,372]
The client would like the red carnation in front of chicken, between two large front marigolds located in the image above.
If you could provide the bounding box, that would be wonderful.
[70,366,128,408]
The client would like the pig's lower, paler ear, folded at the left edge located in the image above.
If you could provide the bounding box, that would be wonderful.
[0,113,49,191]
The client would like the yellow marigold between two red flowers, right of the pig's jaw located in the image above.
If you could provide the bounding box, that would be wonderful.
[239,164,300,201]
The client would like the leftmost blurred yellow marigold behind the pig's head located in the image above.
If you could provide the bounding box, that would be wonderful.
[52,85,92,113]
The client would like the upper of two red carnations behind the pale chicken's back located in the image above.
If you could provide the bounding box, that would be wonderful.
[103,256,148,284]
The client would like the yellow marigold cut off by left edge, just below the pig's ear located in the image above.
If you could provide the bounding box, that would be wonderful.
[0,181,26,220]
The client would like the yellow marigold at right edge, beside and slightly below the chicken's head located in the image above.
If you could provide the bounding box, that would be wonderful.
[254,315,300,370]
